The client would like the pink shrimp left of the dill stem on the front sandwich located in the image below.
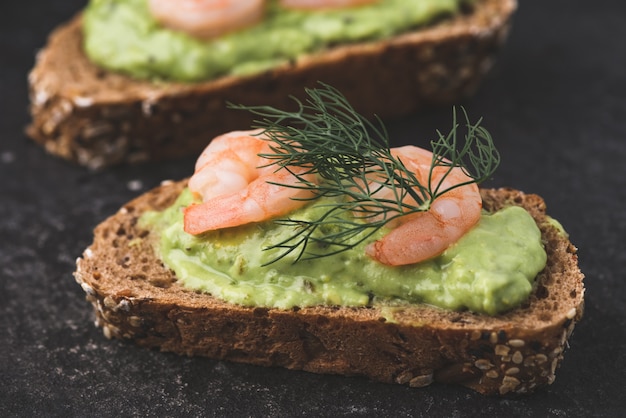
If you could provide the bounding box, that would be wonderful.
[184,131,316,235]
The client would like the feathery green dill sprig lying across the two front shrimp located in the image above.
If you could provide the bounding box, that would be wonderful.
[232,84,500,264]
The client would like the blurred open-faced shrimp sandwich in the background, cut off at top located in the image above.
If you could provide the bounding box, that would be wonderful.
[27,0,516,168]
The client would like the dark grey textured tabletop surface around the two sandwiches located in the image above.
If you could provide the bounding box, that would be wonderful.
[0,0,626,417]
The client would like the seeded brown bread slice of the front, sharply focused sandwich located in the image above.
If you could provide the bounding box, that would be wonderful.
[75,181,584,394]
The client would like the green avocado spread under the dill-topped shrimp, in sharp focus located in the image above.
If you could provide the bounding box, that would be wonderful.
[141,189,546,315]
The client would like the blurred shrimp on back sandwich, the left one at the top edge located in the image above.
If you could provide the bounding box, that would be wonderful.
[148,0,265,39]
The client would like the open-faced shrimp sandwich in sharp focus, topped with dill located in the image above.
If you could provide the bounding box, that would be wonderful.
[75,86,584,394]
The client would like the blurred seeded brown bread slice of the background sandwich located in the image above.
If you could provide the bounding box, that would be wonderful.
[27,0,517,168]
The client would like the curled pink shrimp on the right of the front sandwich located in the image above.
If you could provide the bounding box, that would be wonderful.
[365,146,482,266]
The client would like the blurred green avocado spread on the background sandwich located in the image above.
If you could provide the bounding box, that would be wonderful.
[83,0,467,81]
